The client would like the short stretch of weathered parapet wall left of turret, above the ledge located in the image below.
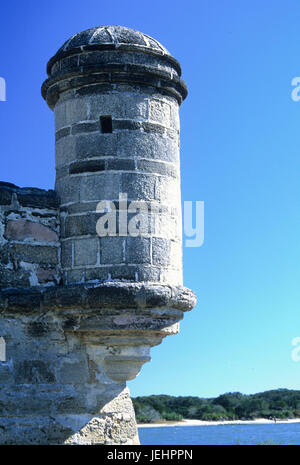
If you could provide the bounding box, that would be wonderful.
[0,182,61,289]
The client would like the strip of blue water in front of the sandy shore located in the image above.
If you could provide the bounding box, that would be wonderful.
[139,423,300,445]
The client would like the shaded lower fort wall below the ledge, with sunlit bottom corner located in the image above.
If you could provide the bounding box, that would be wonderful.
[0,296,138,445]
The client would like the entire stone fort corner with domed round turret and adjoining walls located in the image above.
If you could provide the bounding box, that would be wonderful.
[0,26,195,444]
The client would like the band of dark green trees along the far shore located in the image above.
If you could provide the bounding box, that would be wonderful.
[132,389,300,423]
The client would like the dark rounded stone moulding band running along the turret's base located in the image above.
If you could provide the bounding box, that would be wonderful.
[0,282,196,313]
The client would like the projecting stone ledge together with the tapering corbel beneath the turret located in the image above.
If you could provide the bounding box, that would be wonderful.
[0,282,196,384]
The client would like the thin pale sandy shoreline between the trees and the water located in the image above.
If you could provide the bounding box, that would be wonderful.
[137,418,300,428]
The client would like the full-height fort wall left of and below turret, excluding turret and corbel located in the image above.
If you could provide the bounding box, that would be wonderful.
[0,182,138,445]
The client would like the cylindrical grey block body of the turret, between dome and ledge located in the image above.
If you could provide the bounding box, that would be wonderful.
[54,85,182,285]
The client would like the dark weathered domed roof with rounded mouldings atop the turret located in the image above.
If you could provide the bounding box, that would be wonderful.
[42,25,187,108]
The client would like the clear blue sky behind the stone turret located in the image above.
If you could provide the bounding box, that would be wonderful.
[0,0,300,397]
